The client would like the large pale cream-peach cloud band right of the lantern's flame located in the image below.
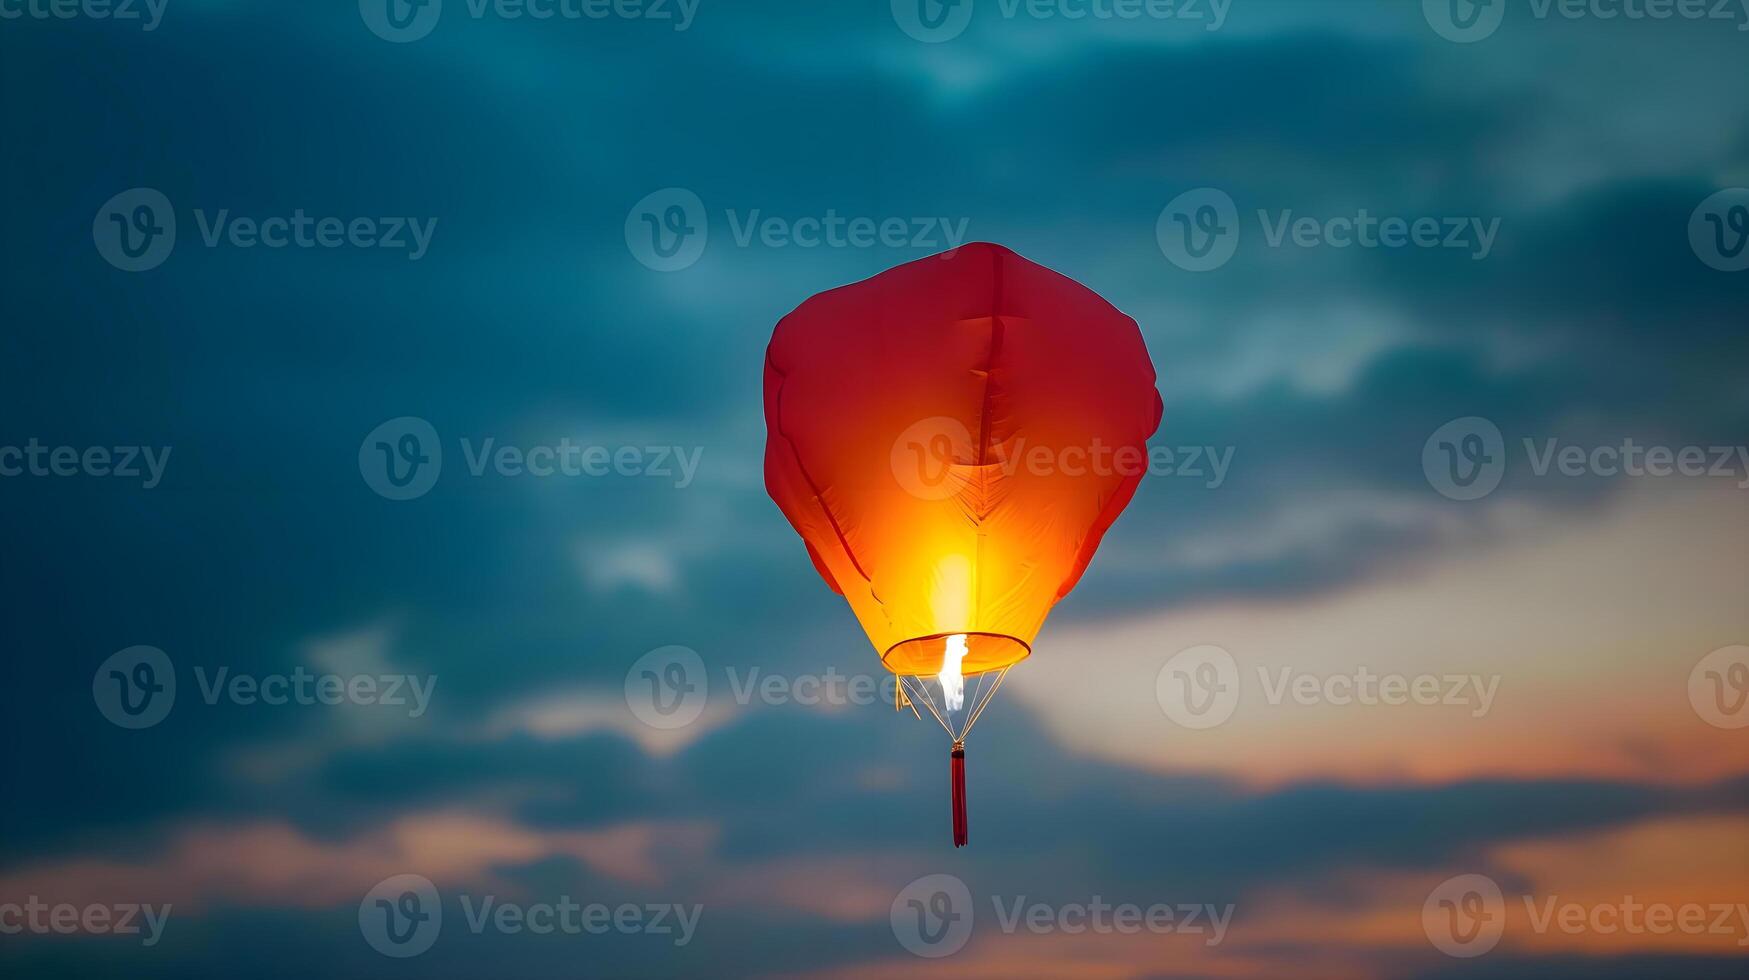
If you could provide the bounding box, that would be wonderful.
[1004,481,1749,784]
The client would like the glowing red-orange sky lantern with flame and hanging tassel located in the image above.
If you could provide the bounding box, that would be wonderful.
[764,243,1160,845]
